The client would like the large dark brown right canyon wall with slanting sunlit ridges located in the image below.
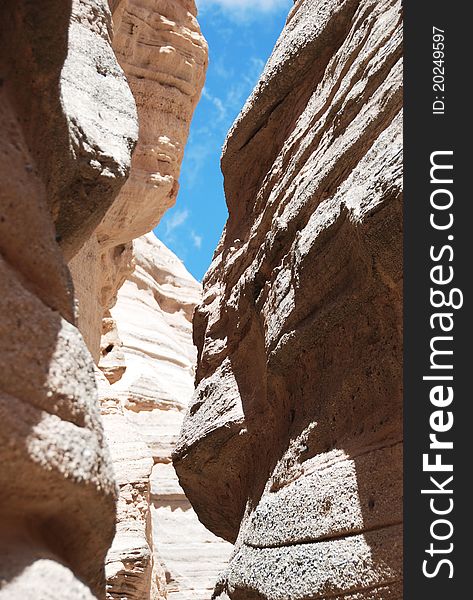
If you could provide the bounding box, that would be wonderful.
[174,0,402,600]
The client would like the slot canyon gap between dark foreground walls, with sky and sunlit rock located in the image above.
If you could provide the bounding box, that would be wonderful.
[70,0,291,600]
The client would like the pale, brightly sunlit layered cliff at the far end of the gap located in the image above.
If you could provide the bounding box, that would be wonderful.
[99,234,231,600]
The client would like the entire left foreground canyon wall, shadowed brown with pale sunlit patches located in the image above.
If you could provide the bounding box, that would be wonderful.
[0,0,137,600]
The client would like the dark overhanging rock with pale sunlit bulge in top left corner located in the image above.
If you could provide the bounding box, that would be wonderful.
[2,0,138,260]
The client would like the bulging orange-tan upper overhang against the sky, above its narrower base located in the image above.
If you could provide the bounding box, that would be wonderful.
[98,0,208,246]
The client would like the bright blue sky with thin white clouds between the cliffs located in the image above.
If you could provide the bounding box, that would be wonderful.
[155,0,293,280]
